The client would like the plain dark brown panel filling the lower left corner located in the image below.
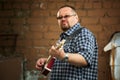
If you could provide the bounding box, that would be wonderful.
[0,57,23,80]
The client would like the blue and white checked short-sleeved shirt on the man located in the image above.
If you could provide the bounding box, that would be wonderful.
[49,23,98,80]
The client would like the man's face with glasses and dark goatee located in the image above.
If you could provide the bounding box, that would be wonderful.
[57,7,78,31]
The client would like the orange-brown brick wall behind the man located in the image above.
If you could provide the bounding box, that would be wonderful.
[0,0,120,80]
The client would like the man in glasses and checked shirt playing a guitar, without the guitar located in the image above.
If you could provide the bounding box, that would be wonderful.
[36,5,98,80]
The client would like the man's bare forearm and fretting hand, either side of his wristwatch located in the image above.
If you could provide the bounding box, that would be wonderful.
[49,46,87,66]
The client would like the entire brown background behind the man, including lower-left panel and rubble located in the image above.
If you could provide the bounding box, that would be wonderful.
[0,0,120,80]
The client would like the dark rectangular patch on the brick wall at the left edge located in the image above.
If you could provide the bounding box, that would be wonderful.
[0,34,18,58]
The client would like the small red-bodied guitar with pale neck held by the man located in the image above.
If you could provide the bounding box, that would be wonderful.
[41,40,66,76]
